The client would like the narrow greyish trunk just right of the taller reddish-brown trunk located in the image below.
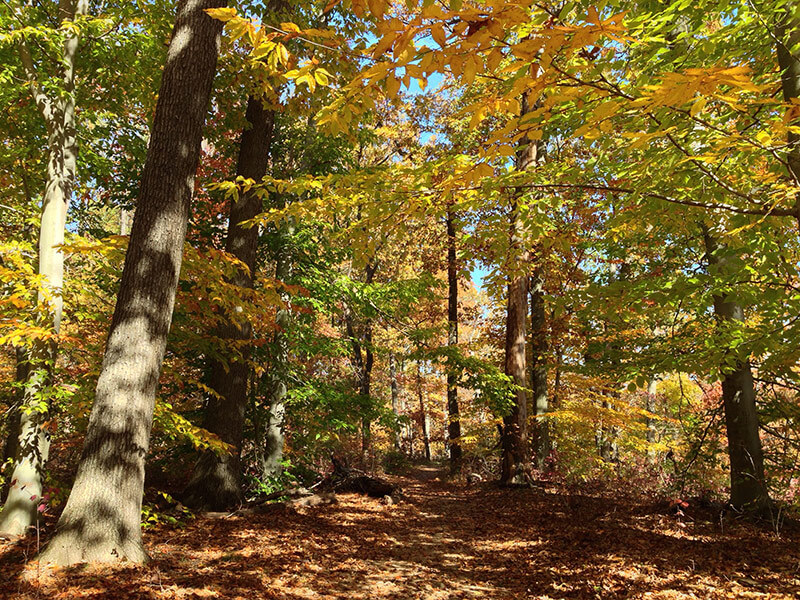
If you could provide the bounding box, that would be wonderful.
[530,269,551,469]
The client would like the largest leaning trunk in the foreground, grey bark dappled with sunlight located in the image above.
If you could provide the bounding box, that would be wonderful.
[41,0,227,565]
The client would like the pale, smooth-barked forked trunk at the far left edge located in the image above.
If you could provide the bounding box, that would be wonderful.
[0,0,89,535]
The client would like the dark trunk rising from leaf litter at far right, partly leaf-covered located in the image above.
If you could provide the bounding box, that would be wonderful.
[703,227,771,512]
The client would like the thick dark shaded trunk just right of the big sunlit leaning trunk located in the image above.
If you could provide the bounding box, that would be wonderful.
[184,96,275,511]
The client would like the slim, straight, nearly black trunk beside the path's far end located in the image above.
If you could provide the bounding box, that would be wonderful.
[447,205,462,474]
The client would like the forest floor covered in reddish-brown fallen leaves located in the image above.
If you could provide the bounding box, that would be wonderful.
[0,467,800,600]
